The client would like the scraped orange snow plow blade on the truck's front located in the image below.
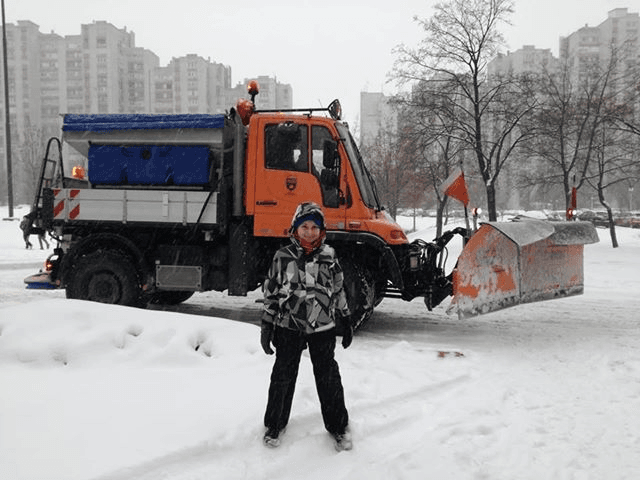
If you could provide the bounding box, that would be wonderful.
[448,218,599,318]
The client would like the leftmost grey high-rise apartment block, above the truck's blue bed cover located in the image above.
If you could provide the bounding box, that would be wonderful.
[1,21,159,140]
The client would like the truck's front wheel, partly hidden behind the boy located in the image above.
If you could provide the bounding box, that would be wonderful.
[342,261,376,330]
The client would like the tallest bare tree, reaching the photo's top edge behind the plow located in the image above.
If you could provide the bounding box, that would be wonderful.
[392,0,535,220]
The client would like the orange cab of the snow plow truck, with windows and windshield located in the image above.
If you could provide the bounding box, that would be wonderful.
[245,107,407,245]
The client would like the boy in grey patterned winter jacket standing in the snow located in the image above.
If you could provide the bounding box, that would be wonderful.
[260,202,353,450]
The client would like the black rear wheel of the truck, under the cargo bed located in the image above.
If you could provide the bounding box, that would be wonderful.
[66,252,141,306]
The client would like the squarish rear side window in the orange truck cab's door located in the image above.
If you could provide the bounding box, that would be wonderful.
[264,122,309,172]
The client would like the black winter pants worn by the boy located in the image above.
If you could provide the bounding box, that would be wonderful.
[264,327,349,433]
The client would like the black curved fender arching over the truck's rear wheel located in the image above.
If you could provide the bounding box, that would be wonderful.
[60,233,148,285]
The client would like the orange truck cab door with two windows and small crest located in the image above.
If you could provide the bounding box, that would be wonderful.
[254,119,346,237]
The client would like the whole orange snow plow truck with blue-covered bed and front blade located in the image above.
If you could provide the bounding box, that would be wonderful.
[25,85,597,326]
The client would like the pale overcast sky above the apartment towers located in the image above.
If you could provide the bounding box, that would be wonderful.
[5,0,640,123]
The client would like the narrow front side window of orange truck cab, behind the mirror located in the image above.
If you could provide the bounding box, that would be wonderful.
[311,125,340,208]
